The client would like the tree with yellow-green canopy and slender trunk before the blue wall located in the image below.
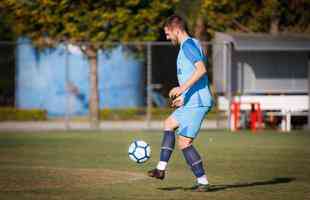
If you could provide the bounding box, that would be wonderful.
[1,0,177,128]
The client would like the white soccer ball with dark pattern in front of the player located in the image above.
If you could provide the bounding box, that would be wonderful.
[128,140,151,164]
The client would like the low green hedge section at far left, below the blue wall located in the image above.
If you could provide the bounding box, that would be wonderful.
[0,107,47,121]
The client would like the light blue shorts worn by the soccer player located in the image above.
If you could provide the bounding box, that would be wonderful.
[171,107,211,138]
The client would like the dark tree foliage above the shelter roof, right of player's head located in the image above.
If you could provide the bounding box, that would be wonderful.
[192,0,310,36]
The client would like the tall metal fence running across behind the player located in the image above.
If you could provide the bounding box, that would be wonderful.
[0,39,309,131]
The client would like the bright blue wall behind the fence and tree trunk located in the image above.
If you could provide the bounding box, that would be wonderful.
[16,39,144,116]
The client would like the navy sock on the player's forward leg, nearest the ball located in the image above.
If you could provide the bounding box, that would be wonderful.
[160,131,175,162]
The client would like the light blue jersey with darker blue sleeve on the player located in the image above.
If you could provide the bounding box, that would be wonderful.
[177,38,213,107]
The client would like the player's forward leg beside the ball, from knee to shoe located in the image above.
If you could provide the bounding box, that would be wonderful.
[148,116,179,179]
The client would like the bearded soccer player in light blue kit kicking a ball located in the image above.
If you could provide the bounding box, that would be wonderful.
[148,15,213,191]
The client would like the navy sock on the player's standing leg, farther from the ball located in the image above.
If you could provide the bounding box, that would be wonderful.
[182,145,205,178]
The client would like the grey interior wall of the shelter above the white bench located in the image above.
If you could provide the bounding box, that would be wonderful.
[232,52,308,94]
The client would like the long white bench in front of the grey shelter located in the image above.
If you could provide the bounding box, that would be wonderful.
[218,95,309,131]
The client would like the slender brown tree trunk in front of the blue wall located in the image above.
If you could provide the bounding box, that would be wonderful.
[86,48,99,129]
